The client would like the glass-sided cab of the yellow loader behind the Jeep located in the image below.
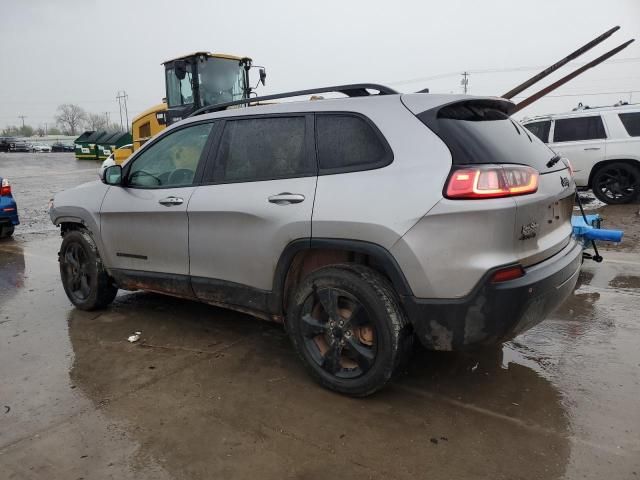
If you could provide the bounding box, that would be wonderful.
[163,52,252,125]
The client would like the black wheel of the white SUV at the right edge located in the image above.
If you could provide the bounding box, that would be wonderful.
[591,162,640,204]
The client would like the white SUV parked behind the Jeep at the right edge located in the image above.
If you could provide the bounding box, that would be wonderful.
[523,104,640,204]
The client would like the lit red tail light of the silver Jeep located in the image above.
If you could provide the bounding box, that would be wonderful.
[445,165,540,199]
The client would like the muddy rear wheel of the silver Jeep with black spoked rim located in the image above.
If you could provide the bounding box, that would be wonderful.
[286,264,413,397]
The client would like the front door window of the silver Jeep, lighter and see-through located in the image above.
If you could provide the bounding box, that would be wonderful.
[127,123,213,188]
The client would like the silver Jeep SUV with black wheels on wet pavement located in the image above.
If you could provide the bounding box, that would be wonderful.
[50,86,582,396]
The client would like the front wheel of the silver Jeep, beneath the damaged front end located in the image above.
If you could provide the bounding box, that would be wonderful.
[58,230,118,310]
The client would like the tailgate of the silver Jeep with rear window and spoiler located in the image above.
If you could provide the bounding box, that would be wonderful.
[403,96,575,267]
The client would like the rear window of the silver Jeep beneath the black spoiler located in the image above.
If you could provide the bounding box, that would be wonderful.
[418,100,564,172]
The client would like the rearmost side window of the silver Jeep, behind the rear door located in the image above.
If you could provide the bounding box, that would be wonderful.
[316,114,393,173]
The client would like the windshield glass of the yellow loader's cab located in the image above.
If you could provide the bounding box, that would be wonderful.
[198,58,245,106]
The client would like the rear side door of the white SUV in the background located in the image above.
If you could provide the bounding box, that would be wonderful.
[549,113,607,187]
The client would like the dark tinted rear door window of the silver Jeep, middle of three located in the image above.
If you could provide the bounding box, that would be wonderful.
[214,116,316,182]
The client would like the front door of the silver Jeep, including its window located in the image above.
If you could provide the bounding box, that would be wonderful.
[100,122,213,295]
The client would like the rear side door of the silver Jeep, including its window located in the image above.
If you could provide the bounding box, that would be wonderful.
[188,114,317,310]
